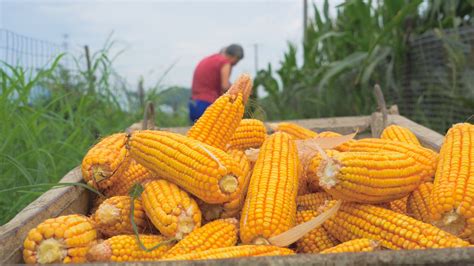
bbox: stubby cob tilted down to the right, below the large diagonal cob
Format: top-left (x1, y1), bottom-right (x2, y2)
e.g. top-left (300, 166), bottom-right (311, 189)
top-left (142, 180), bottom-right (201, 239)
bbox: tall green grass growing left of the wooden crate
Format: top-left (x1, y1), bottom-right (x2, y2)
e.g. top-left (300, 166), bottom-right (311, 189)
top-left (0, 47), bottom-right (187, 224)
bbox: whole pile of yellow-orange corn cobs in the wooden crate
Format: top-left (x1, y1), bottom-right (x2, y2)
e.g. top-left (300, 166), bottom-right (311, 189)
top-left (23, 75), bottom-right (474, 263)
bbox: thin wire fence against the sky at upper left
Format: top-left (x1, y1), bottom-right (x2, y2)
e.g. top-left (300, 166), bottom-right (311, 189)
top-left (0, 29), bottom-right (65, 71)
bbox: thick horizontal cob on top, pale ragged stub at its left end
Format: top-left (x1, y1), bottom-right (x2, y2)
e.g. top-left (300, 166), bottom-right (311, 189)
top-left (318, 152), bottom-right (422, 203)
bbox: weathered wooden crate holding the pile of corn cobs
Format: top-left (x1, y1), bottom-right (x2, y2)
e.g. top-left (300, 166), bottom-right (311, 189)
top-left (0, 113), bottom-right (474, 265)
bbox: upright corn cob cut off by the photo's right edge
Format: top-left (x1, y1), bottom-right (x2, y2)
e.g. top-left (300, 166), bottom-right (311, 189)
top-left (430, 123), bottom-right (474, 242)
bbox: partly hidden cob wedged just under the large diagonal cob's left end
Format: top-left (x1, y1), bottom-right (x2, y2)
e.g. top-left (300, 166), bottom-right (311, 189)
top-left (104, 158), bottom-right (157, 197)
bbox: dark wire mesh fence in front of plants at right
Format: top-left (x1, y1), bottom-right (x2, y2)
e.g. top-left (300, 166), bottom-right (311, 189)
top-left (389, 27), bottom-right (474, 132)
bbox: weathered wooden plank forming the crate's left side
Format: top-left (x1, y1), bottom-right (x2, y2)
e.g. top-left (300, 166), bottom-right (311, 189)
top-left (0, 167), bottom-right (89, 264)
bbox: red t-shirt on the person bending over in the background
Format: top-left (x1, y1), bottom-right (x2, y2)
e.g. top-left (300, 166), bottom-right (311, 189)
top-left (191, 54), bottom-right (230, 103)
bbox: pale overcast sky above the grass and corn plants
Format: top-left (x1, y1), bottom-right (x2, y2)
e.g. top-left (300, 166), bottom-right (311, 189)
top-left (0, 0), bottom-right (341, 87)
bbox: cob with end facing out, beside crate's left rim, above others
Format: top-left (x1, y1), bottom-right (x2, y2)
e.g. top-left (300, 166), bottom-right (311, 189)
top-left (81, 133), bottom-right (127, 190)
